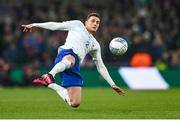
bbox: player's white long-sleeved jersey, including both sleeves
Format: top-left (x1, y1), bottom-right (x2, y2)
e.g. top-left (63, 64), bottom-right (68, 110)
top-left (31, 20), bottom-right (114, 86)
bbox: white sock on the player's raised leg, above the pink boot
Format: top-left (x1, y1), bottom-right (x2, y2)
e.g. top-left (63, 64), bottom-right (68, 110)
top-left (49, 62), bottom-right (66, 77)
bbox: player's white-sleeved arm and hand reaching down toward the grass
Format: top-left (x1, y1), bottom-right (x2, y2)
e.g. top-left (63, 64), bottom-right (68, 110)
top-left (92, 50), bottom-right (125, 95)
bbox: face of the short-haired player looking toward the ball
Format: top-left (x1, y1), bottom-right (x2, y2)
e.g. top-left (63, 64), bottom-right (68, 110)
top-left (85, 16), bottom-right (100, 33)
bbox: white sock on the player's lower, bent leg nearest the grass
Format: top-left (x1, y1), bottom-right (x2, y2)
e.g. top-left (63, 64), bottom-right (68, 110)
top-left (48, 83), bottom-right (71, 105)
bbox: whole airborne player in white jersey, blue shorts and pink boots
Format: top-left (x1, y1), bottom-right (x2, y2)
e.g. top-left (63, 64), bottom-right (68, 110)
top-left (21, 13), bottom-right (124, 107)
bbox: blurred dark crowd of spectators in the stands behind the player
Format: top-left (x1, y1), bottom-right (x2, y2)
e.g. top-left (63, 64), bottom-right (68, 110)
top-left (0, 0), bottom-right (180, 84)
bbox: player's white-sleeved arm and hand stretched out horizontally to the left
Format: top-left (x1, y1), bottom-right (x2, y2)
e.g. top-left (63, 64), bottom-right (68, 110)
top-left (21, 20), bottom-right (81, 32)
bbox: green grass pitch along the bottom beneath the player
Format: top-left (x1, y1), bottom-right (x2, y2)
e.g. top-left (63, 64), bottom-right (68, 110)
top-left (0, 87), bottom-right (180, 119)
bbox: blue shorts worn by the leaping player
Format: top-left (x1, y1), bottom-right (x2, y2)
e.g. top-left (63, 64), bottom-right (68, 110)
top-left (54, 49), bottom-right (83, 88)
